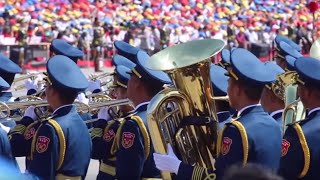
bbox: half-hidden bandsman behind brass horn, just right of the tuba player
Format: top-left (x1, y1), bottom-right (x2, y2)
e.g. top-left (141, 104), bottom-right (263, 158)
top-left (261, 62), bottom-right (285, 129)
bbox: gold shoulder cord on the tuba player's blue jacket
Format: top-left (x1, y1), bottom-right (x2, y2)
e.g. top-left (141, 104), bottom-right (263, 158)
top-left (231, 121), bottom-right (249, 166)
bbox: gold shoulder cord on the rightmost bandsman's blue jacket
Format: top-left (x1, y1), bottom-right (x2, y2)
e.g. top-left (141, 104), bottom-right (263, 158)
top-left (292, 123), bottom-right (310, 178)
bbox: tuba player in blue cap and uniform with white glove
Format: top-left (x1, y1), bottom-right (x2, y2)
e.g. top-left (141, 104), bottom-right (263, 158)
top-left (154, 48), bottom-right (281, 179)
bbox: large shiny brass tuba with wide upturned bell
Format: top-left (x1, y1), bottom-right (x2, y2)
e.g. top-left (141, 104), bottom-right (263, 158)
top-left (146, 39), bottom-right (227, 179)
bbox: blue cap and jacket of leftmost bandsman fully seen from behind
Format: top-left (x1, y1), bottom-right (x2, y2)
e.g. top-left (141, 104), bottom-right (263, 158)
top-left (28, 55), bottom-right (91, 179)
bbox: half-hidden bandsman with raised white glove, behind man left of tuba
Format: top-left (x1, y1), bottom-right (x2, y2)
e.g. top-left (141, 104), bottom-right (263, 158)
top-left (91, 65), bottom-right (132, 180)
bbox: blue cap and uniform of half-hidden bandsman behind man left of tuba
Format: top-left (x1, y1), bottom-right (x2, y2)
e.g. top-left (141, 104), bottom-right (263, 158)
top-left (91, 64), bottom-right (131, 180)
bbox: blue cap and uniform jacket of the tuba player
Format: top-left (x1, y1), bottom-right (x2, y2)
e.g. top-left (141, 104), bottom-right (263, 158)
top-left (176, 48), bottom-right (281, 179)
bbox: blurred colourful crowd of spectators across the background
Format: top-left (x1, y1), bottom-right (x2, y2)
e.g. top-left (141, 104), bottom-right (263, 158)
top-left (0, 0), bottom-right (320, 56)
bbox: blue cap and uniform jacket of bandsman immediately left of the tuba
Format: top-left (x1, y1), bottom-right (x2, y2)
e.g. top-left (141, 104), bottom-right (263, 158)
top-left (114, 51), bottom-right (171, 180)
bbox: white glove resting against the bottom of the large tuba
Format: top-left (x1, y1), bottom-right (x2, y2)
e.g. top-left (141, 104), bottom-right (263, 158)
top-left (153, 144), bottom-right (181, 174)
